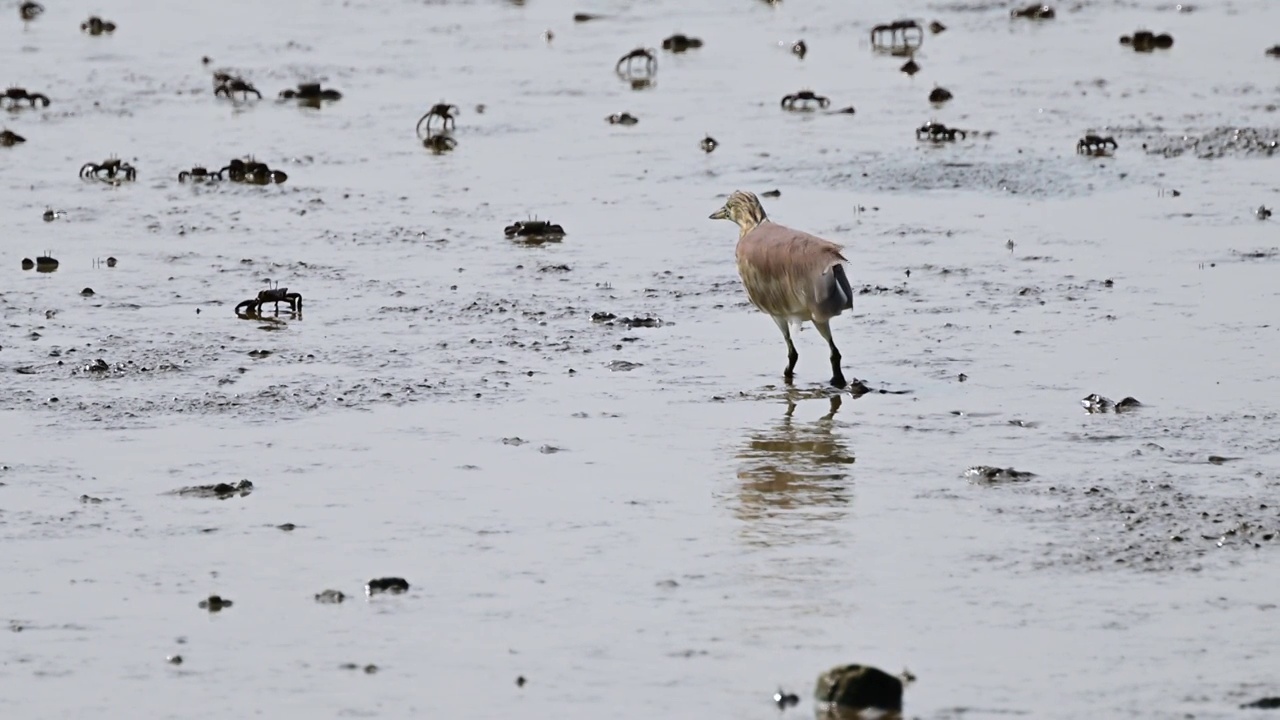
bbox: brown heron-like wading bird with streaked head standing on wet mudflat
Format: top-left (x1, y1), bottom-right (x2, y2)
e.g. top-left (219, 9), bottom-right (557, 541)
top-left (710, 191), bottom-right (854, 387)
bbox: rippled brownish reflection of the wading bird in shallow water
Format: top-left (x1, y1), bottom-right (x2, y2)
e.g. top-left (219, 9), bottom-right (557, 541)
top-left (736, 395), bottom-right (854, 542)
